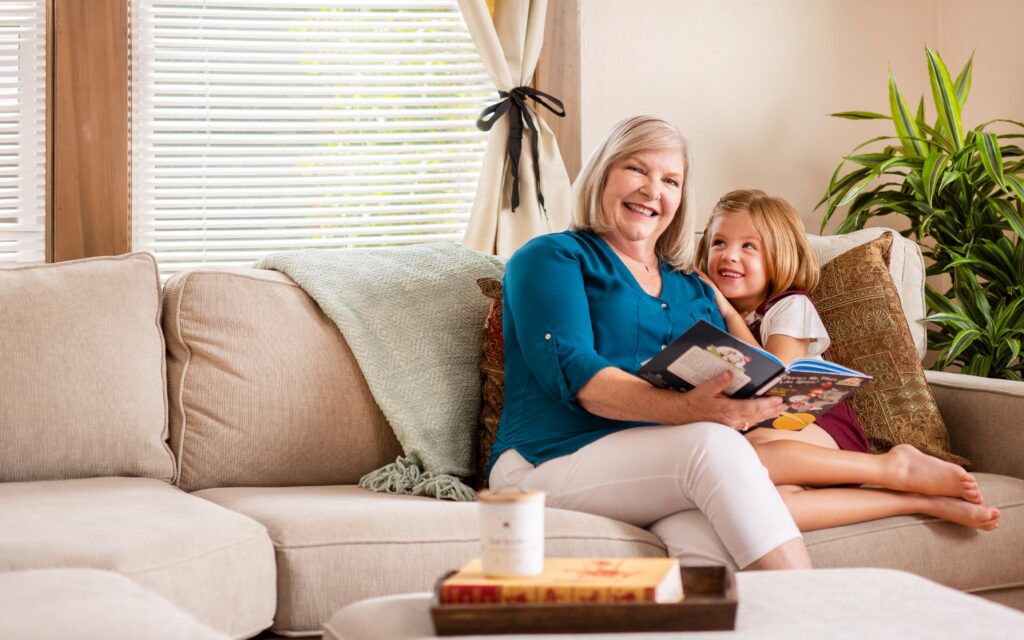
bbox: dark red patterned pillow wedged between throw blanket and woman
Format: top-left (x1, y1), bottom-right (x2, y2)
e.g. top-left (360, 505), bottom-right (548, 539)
top-left (476, 278), bottom-right (505, 489)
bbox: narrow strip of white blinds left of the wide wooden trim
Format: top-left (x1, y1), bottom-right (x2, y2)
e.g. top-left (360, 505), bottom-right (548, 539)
top-left (0, 0), bottom-right (47, 263)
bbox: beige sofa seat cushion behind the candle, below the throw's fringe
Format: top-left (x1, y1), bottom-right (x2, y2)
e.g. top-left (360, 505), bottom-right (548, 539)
top-left (195, 485), bottom-right (666, 634)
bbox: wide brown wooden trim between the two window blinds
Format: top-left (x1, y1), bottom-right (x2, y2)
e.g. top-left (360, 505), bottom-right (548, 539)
top-left (51, 0), bottom-right (131, 261)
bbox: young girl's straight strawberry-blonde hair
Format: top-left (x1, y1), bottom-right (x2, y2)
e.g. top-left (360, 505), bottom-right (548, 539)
top-left (696, 188), bottom-right (820, 295)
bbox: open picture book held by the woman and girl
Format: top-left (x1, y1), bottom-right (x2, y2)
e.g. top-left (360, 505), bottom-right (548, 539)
top-left (637, 321), bottom-right (871, 429)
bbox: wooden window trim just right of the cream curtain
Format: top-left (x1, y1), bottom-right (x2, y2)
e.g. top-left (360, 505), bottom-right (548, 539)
top-left (534, 0), bottom-right (583, 180)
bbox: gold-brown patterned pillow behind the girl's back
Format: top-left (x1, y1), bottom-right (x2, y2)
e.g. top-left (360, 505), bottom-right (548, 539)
top-left (811, 233), bottom-right (970, 467)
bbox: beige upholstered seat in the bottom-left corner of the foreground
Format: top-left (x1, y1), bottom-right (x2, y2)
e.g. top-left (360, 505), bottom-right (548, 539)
top-left (0, 569), bottom-right (228, 640)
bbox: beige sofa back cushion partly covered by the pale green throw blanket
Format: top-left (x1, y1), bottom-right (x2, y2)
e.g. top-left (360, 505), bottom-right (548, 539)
top-left (164, 268), bottom-right (401, 492)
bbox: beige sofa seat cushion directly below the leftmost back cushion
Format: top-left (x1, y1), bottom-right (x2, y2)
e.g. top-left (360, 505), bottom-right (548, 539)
top-left (0, 478), bottom-right (276, 636)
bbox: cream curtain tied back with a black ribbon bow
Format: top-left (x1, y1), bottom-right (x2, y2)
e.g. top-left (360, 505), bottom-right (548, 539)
top-left (459, 0), bottom-right (571, 256)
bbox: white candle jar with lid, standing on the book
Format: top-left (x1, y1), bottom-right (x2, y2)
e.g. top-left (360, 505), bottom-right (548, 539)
top-left (479, 489), bottom-right (544, 578)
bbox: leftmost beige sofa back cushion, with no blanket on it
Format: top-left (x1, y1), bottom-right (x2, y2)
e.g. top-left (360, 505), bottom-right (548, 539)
top-left (0, 253), bottom-right (174, 482)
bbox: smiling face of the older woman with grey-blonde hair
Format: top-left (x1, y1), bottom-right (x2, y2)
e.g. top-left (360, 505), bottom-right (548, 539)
top-left (601, 148), bottom-right (684, 252)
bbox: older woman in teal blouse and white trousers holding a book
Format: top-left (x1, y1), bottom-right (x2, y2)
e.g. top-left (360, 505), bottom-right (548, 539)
top-left (489, 117), bottom-right (810, 568)
